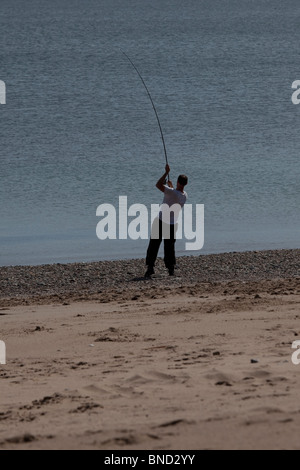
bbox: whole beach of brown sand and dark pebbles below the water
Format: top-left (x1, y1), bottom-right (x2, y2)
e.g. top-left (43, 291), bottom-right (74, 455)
top-left (0, 250), bottom-right (300, 450)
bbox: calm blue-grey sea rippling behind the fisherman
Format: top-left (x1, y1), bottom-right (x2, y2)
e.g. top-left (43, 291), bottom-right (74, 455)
top-left (0, 0), bottom-right (300, 265)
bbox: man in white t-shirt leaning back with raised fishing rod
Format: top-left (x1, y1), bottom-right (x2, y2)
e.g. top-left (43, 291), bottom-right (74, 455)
top-left (145, 165), bottom-right (188, 279)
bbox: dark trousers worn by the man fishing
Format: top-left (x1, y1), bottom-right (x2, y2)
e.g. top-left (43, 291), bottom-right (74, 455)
top-left (146, 219), bottom-right (177, 269)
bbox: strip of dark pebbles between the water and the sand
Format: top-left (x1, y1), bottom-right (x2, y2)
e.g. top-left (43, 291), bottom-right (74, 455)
top-left (0, 249), bottom-right (300, 307)
